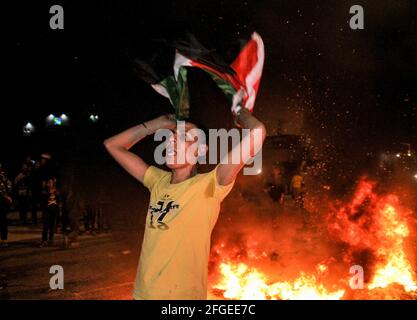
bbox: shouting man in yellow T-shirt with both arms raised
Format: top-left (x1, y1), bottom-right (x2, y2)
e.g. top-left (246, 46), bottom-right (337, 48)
top-left (104, 109), bottom-right (266, 300)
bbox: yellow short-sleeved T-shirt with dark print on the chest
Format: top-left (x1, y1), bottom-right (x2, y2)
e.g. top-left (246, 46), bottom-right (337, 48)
top-left (133, 166), bottom-right (234, 300)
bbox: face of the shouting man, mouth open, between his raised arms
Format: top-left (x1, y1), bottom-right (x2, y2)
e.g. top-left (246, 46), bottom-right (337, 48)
top-left (166, 122), bottom-right (205, 169)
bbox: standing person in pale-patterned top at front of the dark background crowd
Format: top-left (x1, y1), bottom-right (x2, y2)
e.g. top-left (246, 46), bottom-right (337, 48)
top-left (40, 178), bottom-right (59, 247)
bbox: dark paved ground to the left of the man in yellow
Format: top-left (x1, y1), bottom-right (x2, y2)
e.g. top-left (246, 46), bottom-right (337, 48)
top-left (0, 213), bottom-right (140, 300)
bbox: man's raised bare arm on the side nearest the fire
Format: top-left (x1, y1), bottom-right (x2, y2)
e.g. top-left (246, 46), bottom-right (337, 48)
top-left (217, 109), bottom-right (266, 186)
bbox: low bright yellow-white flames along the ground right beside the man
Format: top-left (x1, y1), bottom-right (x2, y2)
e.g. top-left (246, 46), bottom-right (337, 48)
top-left (214, 263), bottom-right (345, 300)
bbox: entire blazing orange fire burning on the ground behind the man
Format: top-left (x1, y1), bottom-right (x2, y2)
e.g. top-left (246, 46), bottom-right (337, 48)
top-left (212, 178), bottom-right (417, 300)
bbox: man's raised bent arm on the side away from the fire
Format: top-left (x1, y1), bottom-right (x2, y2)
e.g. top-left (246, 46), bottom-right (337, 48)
top-left (104, 115), bottom-right (175, 183)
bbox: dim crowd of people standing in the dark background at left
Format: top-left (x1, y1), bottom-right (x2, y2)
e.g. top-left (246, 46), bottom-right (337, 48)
top-left (0, 153), bottom-right (110, 248)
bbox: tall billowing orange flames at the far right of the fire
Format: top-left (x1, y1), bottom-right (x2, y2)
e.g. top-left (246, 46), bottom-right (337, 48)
top-left (329, 178), bottom-right (417, 292)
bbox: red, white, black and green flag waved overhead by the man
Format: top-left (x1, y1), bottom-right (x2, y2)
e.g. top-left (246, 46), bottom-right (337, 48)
top-left (135, 33), bottom-right (265, 119)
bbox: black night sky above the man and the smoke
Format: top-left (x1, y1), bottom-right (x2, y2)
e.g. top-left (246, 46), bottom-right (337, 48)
top-left (4, 0), bottom-right (417, 180)
